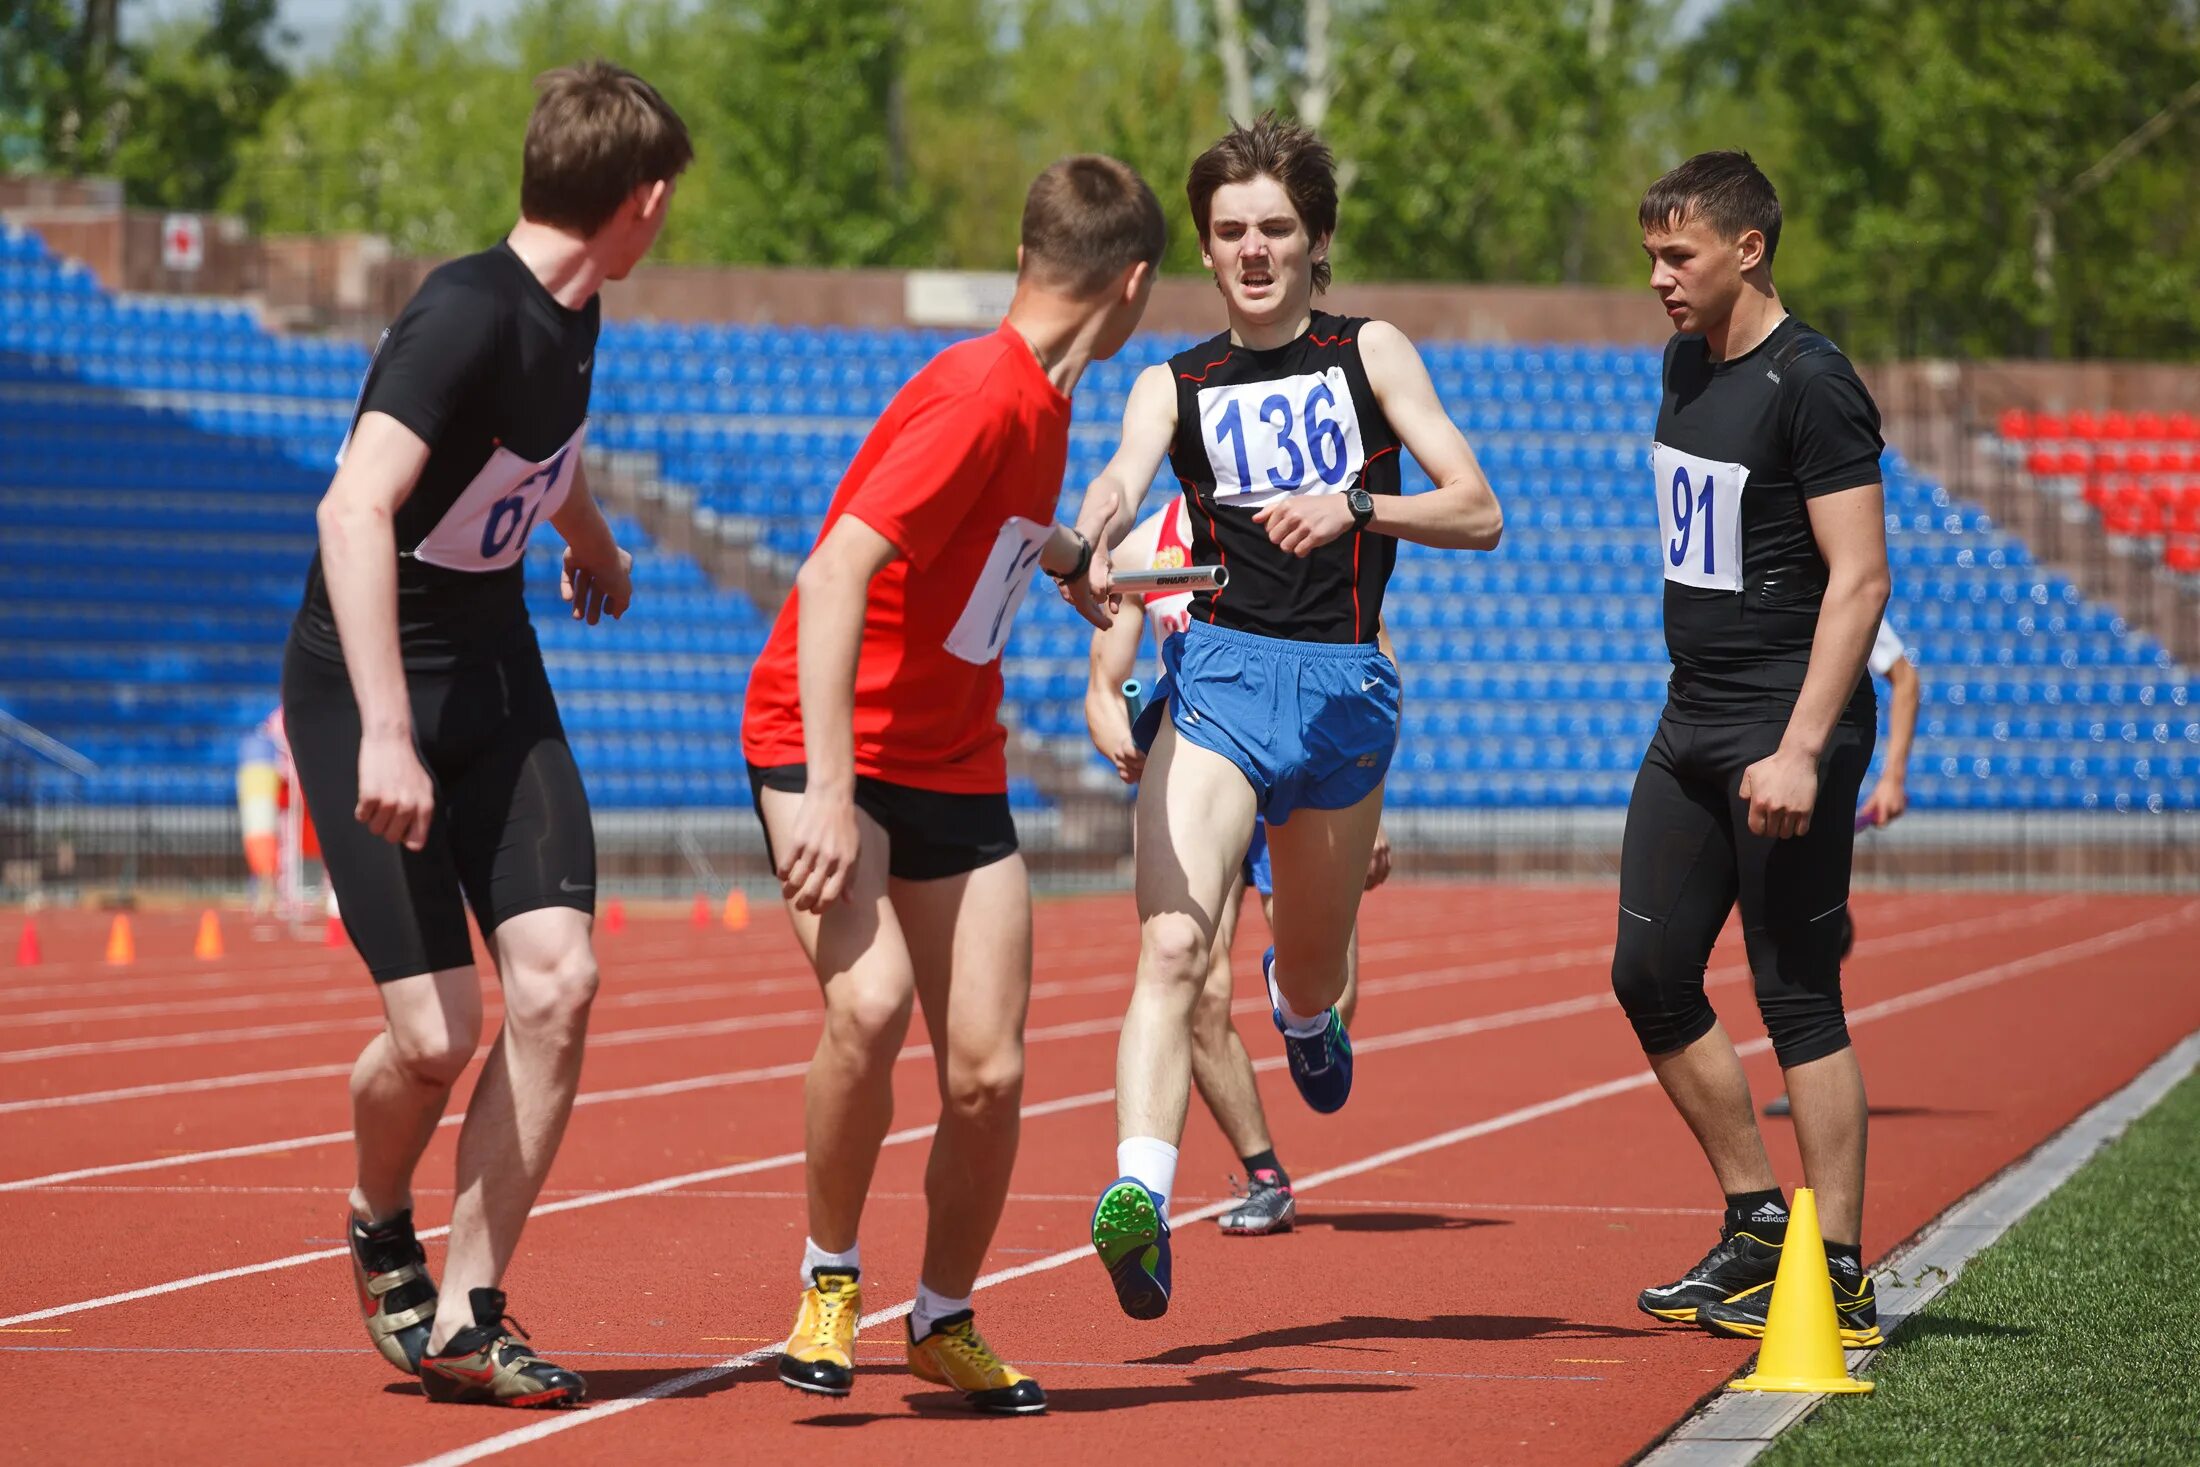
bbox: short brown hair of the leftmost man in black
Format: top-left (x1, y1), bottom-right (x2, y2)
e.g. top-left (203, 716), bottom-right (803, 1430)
top-left (519, 62), bottom-right (695, 235)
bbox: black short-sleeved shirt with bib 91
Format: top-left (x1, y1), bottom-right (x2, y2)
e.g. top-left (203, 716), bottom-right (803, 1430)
top-left (1652, 317), bottom-right (1883, 724)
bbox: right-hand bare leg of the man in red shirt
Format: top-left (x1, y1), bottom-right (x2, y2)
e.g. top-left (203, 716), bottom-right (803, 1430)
top-left (889, 856), bottom-right (1032, 1298)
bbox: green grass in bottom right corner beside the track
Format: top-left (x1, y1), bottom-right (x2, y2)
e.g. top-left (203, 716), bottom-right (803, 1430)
top-left (1758, 1076), bottom-right (2200, 1467)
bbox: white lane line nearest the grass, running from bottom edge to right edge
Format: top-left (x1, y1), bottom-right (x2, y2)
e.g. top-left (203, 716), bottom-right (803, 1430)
top-left (387, 906), bottom-right (2193, 1467)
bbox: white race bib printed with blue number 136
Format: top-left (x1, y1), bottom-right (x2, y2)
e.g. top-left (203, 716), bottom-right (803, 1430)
top-left (1199, 367), bottom-right (1366, 510)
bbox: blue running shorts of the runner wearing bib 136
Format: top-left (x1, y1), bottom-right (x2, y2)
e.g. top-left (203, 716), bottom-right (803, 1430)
top-left (1135, 622), bottom-right (1399, 825)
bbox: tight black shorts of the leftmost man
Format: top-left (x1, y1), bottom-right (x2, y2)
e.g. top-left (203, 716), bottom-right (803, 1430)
top-left (282, 629), bottom-right (596, 983)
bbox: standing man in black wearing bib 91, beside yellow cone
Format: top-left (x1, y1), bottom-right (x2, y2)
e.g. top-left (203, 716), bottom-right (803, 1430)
top-left (1613, 152), bottom-right (1888, 1346)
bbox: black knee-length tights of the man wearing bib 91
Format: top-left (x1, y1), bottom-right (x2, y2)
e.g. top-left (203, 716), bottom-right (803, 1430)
top-left (1613, 717), bottom-right (1874, 1067)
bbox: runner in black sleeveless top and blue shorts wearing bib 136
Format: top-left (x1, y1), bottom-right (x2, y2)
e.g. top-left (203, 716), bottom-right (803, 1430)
top-left (1051, 117), bottom-right (1503, 1317)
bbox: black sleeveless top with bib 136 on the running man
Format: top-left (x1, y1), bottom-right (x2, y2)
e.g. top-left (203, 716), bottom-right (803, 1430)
top-left (1168, 310), bottom-right (1399, 642)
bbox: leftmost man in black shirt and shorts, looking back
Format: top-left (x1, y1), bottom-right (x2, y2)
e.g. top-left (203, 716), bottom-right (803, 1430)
top-left (284, 62), bottom-right (693, 1405)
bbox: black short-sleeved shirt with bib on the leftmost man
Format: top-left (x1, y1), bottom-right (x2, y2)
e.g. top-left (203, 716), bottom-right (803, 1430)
top-left (293, 242), bottom-right (601, 671)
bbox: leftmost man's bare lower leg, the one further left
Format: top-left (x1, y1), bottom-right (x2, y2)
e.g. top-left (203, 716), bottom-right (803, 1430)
top-left (350, 968), bottom-right (482, 1223)
